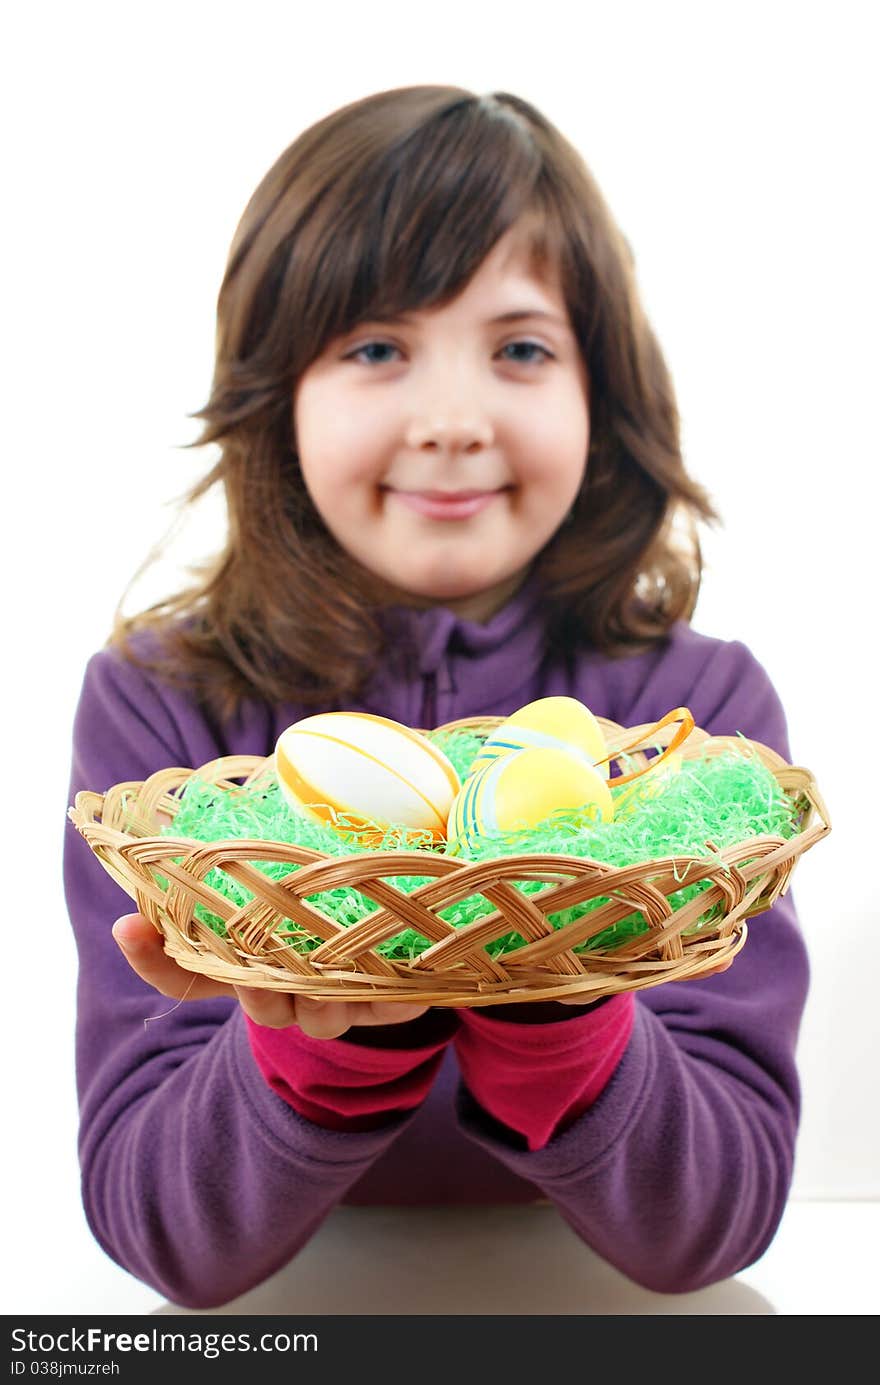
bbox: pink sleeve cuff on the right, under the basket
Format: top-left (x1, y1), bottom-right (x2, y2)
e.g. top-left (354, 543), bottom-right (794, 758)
top-left (455, 992), bottom-right (635, 1150)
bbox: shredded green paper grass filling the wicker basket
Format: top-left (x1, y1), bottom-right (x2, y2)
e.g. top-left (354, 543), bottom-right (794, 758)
top-left (157, 731), bottom-right (800, 960)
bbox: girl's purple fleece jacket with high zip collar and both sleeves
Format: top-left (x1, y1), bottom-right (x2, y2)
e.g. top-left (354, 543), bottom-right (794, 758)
top-left (64, 580), bottom-right (808, 1307)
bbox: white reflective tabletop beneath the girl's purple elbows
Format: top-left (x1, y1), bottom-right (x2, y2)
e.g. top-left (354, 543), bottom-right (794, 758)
top-left (152, 1202), bottom-right (880, 1316)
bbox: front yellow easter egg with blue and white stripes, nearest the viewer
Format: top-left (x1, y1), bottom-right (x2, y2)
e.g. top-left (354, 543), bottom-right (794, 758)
top-left (448, 747), bottom-right (614, 845)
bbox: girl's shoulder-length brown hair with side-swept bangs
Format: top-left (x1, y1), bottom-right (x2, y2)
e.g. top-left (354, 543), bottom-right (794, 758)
top-left (108, 86), bottom-right (718, 717)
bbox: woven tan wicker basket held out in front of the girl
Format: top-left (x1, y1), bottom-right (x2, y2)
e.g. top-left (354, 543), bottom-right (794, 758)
top-left (68, 717), bottom-right (830, 1007)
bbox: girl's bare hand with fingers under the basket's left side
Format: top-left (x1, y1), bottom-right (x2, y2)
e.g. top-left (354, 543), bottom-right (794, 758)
top-left (112, 914), bottom-right (428, 1039)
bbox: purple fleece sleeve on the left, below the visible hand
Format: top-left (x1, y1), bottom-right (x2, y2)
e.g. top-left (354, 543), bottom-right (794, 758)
top-left (64, 651), bottom-right (424, 1307)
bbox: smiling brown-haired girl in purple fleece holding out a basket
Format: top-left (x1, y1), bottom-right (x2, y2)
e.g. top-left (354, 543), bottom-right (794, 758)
top-left (65, 86), bottom-right (808, 1307)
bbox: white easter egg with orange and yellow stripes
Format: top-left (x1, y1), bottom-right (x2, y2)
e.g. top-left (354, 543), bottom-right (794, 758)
top-left (274, 712), bottom-right (460, 841)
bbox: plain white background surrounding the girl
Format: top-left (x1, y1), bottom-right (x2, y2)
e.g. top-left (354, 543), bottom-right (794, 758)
top-left (0, 0), bottom-right (880, 1314)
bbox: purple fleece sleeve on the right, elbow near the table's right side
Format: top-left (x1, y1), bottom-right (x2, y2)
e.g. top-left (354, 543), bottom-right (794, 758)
top-left (459, 641), bottom-right (808, 1292)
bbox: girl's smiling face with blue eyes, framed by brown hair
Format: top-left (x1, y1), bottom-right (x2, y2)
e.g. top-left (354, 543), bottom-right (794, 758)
top-left (294, 231), bottom-right (589, 620)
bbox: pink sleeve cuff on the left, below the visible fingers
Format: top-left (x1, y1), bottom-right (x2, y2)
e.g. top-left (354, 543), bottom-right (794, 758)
top-left (245, 1011), bottom-right (457, 1130)
